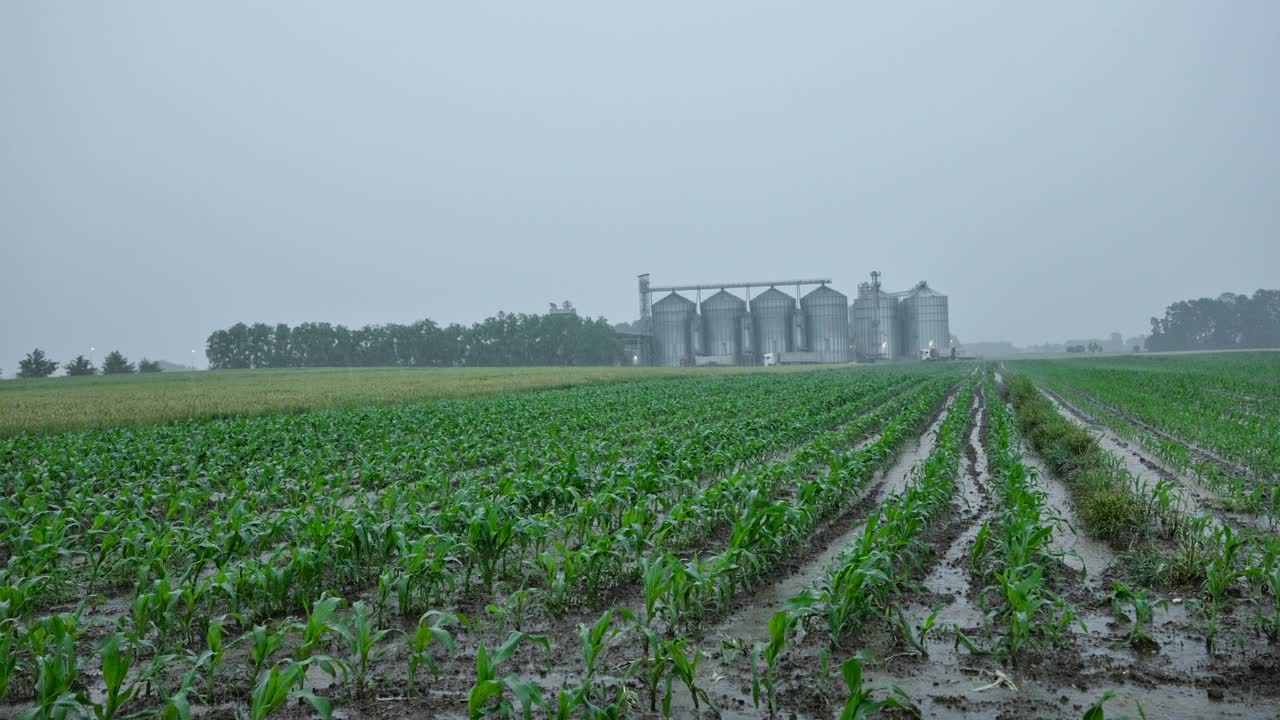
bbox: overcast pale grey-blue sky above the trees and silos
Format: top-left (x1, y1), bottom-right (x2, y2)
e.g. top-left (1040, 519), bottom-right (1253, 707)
top-left (0, 0), bottom-right (1280, 375)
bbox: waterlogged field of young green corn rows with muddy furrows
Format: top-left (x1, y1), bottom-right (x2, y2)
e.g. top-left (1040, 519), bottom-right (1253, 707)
top-left (0, 356), bottom-right (1280, 720)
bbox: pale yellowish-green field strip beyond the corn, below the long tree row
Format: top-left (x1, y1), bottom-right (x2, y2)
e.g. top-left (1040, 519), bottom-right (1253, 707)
top-left (0, 366), bottom-right (829, 437)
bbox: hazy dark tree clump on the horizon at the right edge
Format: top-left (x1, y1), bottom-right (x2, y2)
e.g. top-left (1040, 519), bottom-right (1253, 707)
top-left (1147, 290), bottom-right (1280, 351)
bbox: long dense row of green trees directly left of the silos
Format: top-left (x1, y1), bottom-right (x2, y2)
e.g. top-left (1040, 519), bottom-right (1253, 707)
top-left (205, 313), bottom-right (622, 369)
